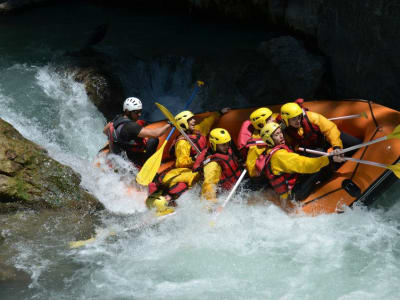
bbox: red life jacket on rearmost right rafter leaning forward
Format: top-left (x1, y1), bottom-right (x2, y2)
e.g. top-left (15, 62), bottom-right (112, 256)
top-left (286, 108), bottom-right (325, 148)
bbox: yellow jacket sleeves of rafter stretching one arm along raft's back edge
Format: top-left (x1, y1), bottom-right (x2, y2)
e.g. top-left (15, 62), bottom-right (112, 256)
top-left (175, 112), bottom-right (220, 168)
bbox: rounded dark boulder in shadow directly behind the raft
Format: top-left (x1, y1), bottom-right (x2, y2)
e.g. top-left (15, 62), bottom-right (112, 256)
top-left (193, 36), bottom-right (327, 109)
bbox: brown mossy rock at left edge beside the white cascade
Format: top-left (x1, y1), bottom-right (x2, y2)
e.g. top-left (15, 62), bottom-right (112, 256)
top-left (0, 119), bottom-right (102, 212)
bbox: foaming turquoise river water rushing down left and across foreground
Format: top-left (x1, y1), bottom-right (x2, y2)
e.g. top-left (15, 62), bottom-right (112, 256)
top-left (0, 2), bottom-right (400, 300)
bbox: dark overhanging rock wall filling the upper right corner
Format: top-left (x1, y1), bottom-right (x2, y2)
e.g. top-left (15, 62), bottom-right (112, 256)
top-left (188, 0), bottom-right (400, 108)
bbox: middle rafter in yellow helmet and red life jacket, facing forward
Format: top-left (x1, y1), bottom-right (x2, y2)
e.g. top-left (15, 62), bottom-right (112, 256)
top-left (194, 128), bottom-right (243, 204)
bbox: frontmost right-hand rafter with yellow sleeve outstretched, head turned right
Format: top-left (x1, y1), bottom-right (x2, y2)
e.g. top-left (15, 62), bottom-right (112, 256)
top-left (256, 122), bottom-right (344, 201)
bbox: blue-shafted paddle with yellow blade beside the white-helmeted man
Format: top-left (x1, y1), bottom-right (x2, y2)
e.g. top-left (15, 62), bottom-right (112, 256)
top-left (136, 81), bottom-right (204, 185)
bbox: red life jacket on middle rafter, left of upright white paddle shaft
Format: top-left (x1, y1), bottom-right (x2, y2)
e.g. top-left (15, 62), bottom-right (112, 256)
top-left (202, 149), bottom-right (242, 190)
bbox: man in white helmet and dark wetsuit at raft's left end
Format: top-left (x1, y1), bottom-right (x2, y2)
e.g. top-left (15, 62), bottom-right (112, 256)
top-left (103, 97), bottom-right (171, 167)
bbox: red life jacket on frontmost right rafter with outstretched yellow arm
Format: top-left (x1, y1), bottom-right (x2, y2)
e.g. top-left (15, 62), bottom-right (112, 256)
top-left (264, 145), bottom-right (297, 195)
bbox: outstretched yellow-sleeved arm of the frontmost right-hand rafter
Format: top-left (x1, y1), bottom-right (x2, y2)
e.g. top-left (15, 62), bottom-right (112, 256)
top-left (271, 149), bottom-right (329, 175)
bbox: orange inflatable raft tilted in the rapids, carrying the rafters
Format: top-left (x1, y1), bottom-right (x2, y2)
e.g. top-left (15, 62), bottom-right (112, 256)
top-left (99, 100), bottom-right (400, 215)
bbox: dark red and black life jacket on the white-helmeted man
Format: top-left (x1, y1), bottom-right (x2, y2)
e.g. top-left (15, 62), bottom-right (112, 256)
top-left (107, 116), bottom-right (146, 154)
